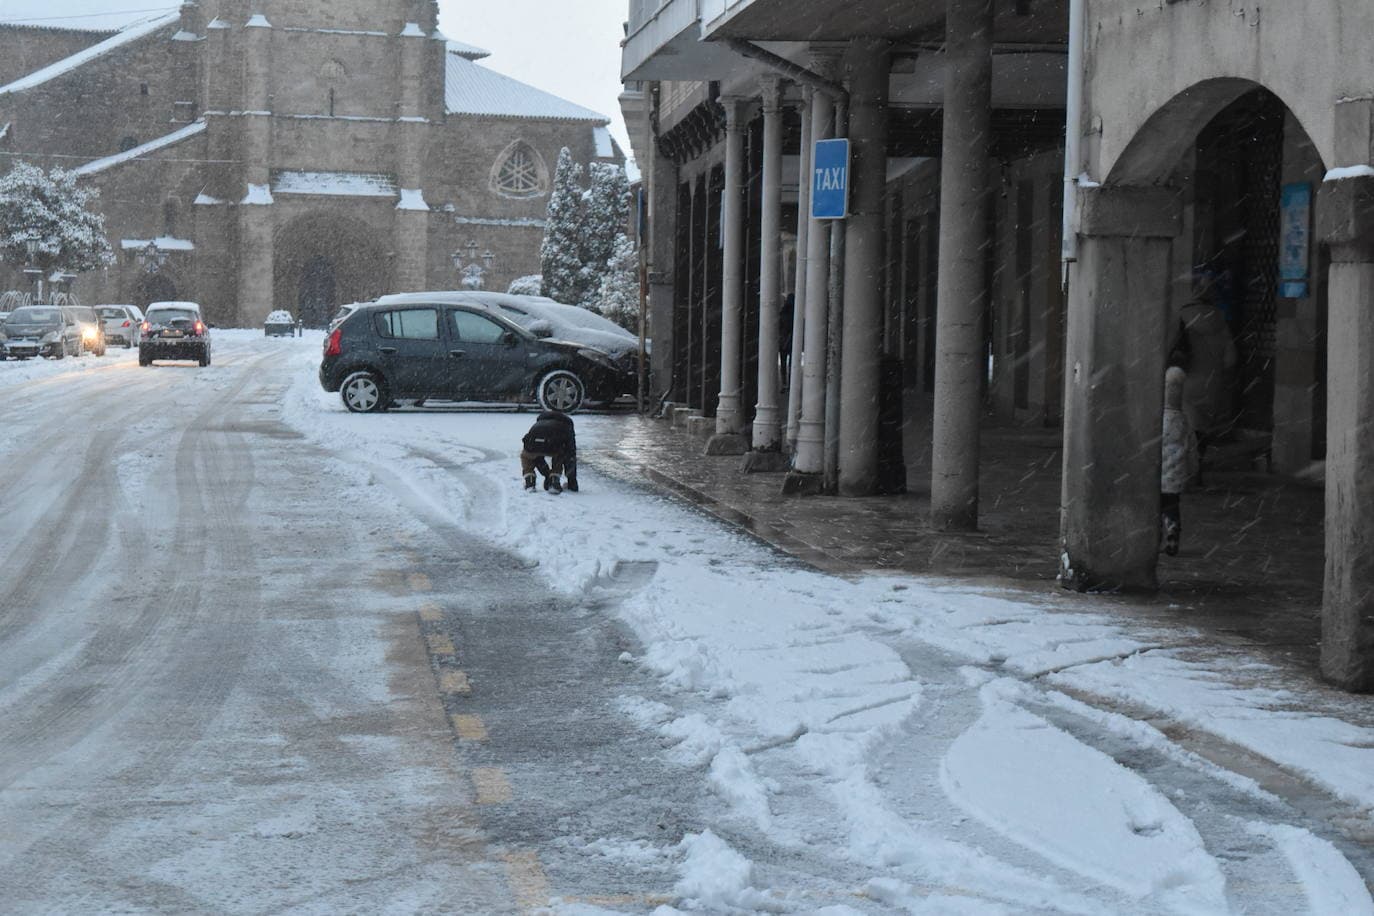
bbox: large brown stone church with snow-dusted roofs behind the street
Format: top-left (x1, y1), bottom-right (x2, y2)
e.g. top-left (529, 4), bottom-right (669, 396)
top-left (0, 0), bottom-right (624, 325)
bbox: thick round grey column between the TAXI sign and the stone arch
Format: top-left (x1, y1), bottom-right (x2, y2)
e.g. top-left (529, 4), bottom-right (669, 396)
top-left (930, 0), bottom-right (992, 531)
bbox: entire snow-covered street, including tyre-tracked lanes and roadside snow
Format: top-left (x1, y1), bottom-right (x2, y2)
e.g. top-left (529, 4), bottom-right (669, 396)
top-left (0, 332), bottom-right (1374, 916)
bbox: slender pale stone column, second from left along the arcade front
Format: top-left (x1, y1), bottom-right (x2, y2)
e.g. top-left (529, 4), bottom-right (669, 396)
top-left (745, 76), bottom-right (787, 471)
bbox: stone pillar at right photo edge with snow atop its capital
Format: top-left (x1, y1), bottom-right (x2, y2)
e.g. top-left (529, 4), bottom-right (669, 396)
top-left (1318, 171), bottom-right (1374, 692)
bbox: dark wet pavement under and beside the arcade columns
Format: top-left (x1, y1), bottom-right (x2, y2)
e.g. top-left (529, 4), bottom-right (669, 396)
top-left (588, 416), bottom-right (1323, 674)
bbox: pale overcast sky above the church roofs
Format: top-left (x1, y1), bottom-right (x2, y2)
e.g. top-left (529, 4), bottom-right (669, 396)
top-left (0, 0), bottom-right (629, 155)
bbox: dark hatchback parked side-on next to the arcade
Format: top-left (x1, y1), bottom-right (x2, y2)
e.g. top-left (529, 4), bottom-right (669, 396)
top-left (320, 293), bottom-right (620, 412)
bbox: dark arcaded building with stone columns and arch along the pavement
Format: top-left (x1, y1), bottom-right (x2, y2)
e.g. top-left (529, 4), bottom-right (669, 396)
top-left (622, 0), bottom-right (1374, 691)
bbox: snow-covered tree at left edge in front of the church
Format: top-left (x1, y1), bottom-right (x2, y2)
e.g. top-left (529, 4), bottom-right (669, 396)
top-left (0, 162), bottom-right (114, 273)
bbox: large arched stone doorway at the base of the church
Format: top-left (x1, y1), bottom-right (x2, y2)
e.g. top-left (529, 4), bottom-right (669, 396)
top-left (273, 213), bottom-right (392, 328)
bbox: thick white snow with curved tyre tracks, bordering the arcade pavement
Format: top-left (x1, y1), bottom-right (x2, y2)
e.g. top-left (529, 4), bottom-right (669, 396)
top-left (262, 336), bottom-right (1374, 913)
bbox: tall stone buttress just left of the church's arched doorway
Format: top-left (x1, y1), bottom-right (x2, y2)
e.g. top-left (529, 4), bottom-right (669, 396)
top-left (238, 4), bottom-right (276, 327)
